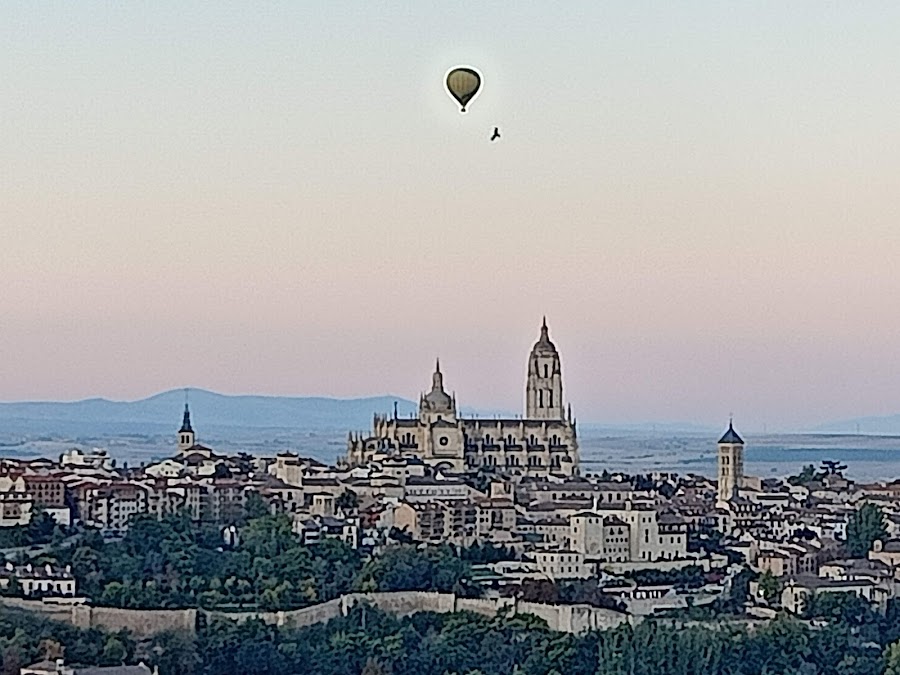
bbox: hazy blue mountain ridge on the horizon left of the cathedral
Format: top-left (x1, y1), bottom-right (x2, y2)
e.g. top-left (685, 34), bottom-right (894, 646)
top-left (0, 389), bottom-right (416, 435)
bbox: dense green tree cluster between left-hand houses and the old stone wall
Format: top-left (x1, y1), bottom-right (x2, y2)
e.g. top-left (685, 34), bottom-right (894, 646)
top-left (41, 515), bottom-right (477, 611)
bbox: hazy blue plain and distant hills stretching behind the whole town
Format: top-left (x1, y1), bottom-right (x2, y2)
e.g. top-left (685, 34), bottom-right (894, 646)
top-left (0, 389), bottom-right (900, 481)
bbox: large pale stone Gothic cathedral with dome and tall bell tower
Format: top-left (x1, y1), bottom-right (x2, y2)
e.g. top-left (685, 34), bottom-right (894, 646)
top-left (342, 319), bottom-right (578, 478)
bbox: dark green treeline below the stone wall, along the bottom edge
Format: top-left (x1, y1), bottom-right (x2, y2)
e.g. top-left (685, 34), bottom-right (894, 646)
top-left (0, 603), bottom-right (900, 675)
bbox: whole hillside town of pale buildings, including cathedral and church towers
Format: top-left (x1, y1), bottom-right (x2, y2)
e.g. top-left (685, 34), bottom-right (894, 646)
top-left (0, 320), bottom-right (900, 636)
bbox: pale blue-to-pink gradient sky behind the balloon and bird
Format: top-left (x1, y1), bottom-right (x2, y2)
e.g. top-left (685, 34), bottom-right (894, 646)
top-left (0, 0), bottom-right (900, 430)
